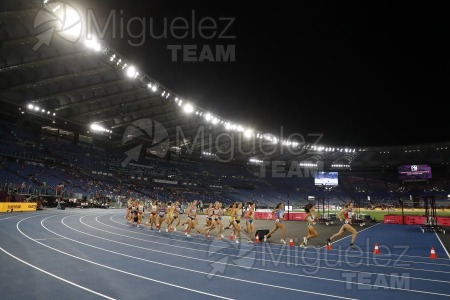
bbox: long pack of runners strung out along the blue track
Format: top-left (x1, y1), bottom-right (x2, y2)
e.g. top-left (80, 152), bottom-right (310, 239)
top-left (125, 199), bottom-right (358, 249)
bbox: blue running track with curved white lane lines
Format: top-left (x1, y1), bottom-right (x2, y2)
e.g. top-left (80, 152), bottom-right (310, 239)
top-left (0, 209), bottom-right (450, 300)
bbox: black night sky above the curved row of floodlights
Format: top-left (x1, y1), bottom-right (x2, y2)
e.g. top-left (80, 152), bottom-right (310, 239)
top-left (77, 0), bottom-right (450, 146)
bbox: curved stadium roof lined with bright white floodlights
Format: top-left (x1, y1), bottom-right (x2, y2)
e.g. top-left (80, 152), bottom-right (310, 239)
top-left (0, 0), bottom-right (449, 168)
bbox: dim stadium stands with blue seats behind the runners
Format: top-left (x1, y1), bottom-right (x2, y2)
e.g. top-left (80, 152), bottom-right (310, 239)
top-left (0, 121), bottom-right (448, 207)
